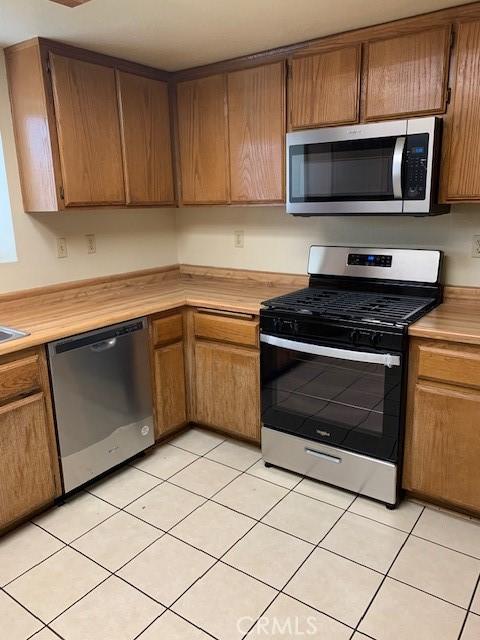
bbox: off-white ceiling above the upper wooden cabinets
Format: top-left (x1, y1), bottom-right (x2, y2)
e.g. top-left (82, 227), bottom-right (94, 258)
top-left (0, 0), bottom-right (472, 71)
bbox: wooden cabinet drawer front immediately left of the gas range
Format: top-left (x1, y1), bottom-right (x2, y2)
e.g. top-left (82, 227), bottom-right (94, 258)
top-left (194, 312), bottom-right (258, 347)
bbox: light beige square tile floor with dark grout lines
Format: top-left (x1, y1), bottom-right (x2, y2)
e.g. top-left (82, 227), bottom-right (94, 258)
top-left (0, 429), bottom-right (480, 640)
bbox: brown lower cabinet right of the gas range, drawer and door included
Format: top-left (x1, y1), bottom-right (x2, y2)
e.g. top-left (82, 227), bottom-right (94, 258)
top-left (403, 339), bottom-right (480, 513)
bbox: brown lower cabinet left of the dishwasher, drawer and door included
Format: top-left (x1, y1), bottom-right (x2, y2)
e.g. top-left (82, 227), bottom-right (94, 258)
top-left (0, 350), bottom-right (60, 530)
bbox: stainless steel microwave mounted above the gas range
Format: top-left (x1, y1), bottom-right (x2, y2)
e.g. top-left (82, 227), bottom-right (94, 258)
top-left (286, 117), bottom-right (450, 216)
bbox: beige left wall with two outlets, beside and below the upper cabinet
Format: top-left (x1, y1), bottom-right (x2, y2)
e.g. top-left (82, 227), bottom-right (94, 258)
top-left (0, 51), bottom-right (177, 294)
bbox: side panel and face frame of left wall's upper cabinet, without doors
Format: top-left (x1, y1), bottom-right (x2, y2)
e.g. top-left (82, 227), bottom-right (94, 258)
top-left (5, 38), bottom-right (175, 213)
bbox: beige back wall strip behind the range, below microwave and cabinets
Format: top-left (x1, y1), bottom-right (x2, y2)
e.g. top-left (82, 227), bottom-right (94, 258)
top-left (177, 205), bottom-right (480, 286)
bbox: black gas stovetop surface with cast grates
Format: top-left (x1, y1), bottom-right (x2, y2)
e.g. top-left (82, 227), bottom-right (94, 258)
top-left (262, 287), bottom-right (435, 324)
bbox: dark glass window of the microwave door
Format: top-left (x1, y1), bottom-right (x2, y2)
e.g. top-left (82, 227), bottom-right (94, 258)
top-left (289, 136), bottom-right (397, 202)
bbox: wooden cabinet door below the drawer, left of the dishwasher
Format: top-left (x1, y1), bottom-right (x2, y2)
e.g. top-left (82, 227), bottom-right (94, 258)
top-left (0, 393), bottom-right (55, 529)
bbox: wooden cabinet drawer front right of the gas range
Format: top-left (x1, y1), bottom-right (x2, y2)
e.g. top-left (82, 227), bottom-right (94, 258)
top-left (418, 346), bottom-right (480, 388)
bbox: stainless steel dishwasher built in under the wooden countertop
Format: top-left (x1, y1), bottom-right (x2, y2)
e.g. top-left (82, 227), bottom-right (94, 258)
top-left (48, 318), bottom-right (154, 493)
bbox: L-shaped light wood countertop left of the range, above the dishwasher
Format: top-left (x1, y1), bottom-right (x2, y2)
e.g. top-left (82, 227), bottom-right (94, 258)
top-left (0, 267), bottom-right (307, 355)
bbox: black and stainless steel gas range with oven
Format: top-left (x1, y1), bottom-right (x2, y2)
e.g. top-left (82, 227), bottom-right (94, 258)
top-left (260, 246), bottom-right (442, 507)
